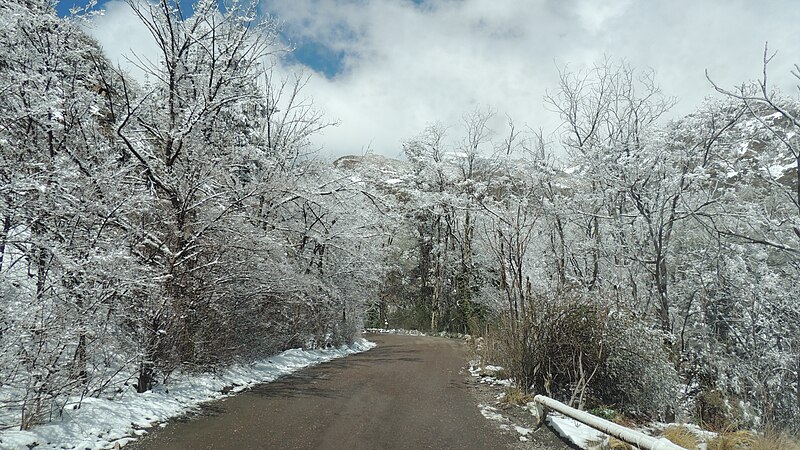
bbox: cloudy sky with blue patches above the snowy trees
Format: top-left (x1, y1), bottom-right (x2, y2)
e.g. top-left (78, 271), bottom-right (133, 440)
top-left (75, 0), bottom-right (800, 157)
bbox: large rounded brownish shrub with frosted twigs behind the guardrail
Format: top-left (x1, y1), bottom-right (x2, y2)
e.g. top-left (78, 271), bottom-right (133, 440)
top-left (503, 297), bottom-right (678, 417)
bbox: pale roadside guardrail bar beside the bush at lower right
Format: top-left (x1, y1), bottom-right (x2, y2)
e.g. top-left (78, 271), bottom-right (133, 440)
top-left (533, 395), bottom-right (686, 450)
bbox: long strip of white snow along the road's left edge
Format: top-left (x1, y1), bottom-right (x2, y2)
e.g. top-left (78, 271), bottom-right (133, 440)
top-left (0, 339), bottom-right (375, 450)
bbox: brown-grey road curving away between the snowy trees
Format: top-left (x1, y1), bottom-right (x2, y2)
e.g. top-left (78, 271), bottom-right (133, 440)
top-left (131, 335), bottom-right (518, 449)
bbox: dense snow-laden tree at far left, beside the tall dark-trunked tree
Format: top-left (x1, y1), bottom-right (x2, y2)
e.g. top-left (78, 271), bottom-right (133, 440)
top-left (0, 2), bottom-right (141, 428)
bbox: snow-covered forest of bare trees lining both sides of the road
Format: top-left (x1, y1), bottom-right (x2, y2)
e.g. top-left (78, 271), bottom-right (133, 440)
top-left (0, 0), bottom-right (800, 438)
